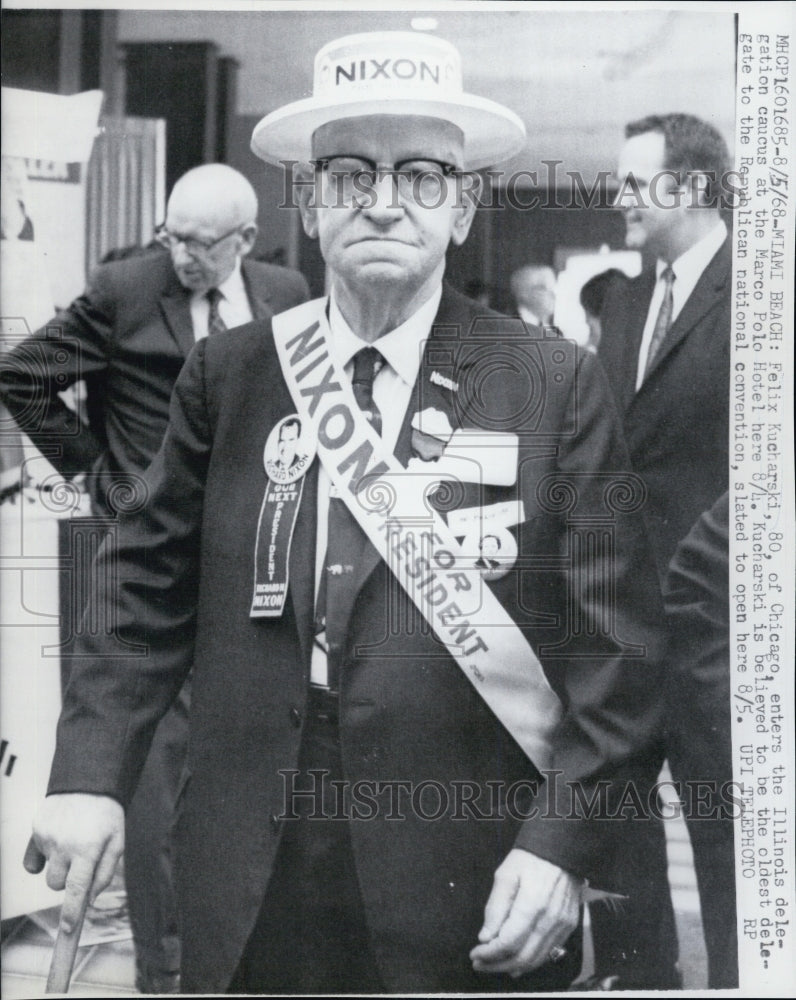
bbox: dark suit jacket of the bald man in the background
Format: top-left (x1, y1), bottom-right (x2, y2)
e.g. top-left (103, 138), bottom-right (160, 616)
top-left (0, 249), bottom-right (308, 510)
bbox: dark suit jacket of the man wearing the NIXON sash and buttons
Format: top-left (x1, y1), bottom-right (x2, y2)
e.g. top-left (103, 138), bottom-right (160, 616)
top-left (50, 289), bottom-right (662, 993)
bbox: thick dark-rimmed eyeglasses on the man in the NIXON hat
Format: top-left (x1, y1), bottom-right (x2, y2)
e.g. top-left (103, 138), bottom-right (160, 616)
top-left (312, 156), bottom-right (460, 207)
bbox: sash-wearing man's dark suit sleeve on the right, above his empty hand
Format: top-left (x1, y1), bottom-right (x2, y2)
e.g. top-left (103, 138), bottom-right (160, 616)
top-left (517, 355), bottom-right (666, 891)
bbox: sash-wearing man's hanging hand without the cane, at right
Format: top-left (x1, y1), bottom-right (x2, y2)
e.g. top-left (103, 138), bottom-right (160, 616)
top-left (470, 848), bottom-right (582, 977)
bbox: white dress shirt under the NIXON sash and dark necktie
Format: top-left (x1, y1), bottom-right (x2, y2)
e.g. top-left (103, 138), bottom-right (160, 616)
top-left (310, 285), bottom-right (442, 686)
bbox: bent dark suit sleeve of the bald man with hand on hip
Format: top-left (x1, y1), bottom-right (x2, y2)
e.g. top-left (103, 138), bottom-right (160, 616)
top-left (0, 267), bottom-right (115, 478)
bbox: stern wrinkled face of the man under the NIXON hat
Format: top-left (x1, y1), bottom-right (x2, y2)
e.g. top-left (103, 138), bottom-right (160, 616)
top-left (302, 115), bottom-right (477, 289)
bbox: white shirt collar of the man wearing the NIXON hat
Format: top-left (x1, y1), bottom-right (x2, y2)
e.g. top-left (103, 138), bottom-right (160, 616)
top-left (329, 285), bottom-right (442, 387)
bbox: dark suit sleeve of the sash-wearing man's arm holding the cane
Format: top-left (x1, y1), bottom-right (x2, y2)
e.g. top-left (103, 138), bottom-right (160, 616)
top-left (48, 341), bottom-right (211, 806)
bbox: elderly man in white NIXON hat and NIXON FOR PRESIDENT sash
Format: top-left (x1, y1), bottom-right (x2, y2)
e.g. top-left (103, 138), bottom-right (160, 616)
top-left (27, 32), bottom-right (662, 993)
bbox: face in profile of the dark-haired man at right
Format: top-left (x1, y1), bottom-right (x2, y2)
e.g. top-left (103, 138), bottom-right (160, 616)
top-left (615, 132), bottom-right (685, 259)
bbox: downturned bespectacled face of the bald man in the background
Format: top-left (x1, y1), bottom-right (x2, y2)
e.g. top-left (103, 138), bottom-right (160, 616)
top-left (161, 193), bottom-right (253, 292)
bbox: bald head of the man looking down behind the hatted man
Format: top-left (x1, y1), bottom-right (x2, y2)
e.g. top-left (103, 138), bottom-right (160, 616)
top-left (164, 163), bottom-right (257, 292)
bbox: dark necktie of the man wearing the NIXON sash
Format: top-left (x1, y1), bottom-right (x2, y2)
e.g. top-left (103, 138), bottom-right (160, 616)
top-left (315, 347), bottom-right (384, 691)
